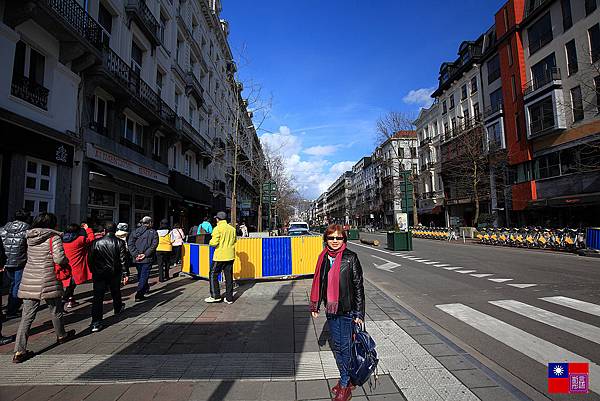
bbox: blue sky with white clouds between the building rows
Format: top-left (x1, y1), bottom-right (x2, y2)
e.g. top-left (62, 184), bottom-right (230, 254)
top-left (222, 0), bottom-right (504, 199)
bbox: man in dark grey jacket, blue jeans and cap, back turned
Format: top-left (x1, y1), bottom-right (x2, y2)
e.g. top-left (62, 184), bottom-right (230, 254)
top-left (127, 216), bottom-right (158, 301)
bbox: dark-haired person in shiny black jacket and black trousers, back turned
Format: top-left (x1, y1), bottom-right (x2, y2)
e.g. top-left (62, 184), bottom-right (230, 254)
top-left (89, 222), bottom-right (129, 333)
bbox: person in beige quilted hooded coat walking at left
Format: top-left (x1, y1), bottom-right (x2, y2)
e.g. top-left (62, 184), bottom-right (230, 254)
top-left (13, 213), bottom-right (75, 363)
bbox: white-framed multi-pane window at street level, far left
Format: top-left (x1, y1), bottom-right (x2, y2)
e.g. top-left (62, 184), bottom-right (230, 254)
top-left (23, 158), bottom-right (56, 216)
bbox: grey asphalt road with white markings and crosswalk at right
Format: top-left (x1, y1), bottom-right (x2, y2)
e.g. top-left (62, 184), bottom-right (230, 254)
top-left (350, 233), bottom-right (600, 400)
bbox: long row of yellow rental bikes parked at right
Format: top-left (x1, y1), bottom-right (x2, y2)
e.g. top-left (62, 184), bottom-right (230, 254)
top-left (475, 227), bottom-right (585, 252)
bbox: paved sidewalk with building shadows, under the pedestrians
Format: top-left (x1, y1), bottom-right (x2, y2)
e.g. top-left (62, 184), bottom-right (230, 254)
top-left (0, 264), bottom-right (515, 401)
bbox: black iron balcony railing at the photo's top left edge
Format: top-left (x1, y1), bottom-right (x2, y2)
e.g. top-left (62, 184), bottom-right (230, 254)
top-left (42, 0), bottom-right (102, 49)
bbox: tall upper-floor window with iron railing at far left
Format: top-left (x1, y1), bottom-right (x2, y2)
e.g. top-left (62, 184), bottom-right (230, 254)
top-left (11, 40), bottom-right (49, 110)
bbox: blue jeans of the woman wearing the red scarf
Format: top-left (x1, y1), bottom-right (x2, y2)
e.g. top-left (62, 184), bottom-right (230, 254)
top-left (327, 314), bottom-right (352, 387)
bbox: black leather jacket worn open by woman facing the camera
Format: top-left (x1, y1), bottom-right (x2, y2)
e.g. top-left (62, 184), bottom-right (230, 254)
top-left (317, 249), bottom-right (365, 320)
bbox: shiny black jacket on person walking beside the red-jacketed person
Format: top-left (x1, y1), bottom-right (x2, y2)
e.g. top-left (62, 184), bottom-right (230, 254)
top-left (88, 233), bottom-right (129, 278)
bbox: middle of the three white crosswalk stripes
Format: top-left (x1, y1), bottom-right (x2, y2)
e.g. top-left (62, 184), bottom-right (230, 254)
top-left (489, 299), bottom-right (600, 344)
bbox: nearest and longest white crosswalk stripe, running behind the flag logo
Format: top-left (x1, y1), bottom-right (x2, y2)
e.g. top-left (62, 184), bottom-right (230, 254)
top-left (436, 304), bottom-right (600, 394)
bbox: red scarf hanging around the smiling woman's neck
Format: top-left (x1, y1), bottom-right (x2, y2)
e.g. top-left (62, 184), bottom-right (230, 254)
top-left (310, 244), bottom-right (346, 314)
